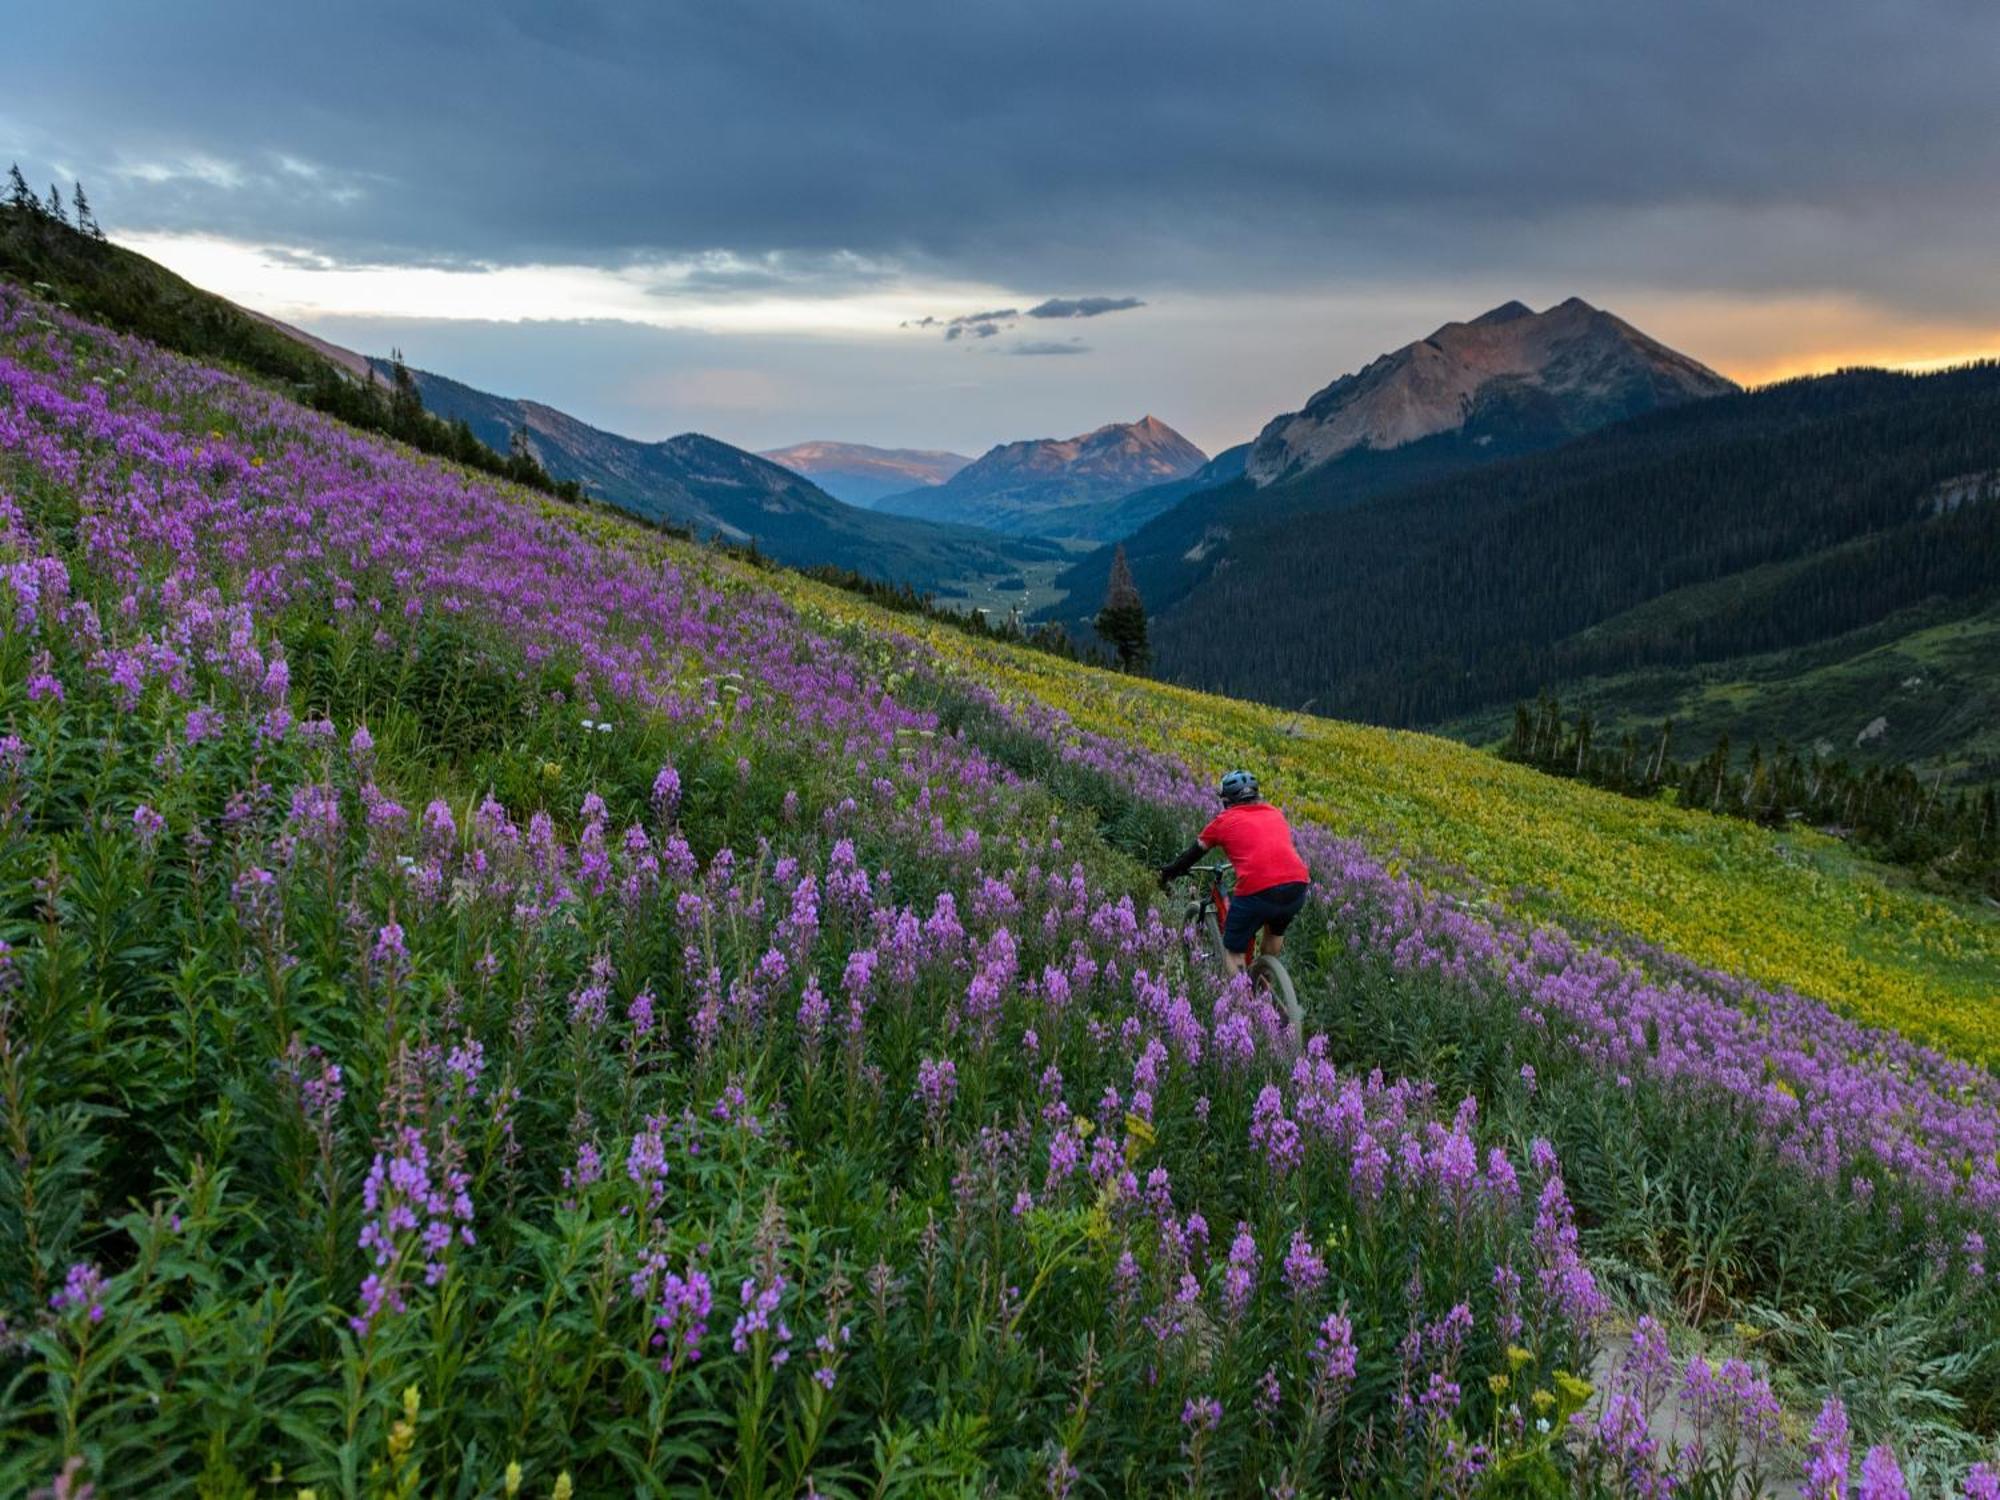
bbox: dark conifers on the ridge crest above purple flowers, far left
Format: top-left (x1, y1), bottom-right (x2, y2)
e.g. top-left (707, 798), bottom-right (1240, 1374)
top-left (0, 166), bottom-right (584, 500)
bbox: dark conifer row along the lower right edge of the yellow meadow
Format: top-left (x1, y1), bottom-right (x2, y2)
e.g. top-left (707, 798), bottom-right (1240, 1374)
top-left (1500, 692), bottom-right (2000, 900)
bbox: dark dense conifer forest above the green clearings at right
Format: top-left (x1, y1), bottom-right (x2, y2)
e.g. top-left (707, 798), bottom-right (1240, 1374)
top-left (1154, 362), bottom-right (2000, 724)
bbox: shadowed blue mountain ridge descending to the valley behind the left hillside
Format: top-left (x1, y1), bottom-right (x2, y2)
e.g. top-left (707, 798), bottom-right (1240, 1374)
top-left (374, 360), bottom-right (1054, 588)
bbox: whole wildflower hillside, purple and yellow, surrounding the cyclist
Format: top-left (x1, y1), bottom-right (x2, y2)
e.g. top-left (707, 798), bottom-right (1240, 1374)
top-left (0, 288), bottom-right (2000, 1500)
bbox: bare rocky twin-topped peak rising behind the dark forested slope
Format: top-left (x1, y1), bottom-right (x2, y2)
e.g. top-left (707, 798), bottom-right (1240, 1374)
top-left (1246, 296), bottom-right (1736, 488)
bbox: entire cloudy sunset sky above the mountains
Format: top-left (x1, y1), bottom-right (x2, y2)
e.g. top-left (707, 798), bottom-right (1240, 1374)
top-left (0, 0), bottom-right (2000, 452)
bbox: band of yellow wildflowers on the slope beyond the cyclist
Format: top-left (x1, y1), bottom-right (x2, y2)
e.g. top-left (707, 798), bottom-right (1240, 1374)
top-left (788, 576), bottom-right (2000, 1060)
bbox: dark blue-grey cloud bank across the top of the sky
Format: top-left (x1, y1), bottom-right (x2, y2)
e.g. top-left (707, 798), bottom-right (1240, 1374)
top-left (11, 0), bottom-right (2000, 312)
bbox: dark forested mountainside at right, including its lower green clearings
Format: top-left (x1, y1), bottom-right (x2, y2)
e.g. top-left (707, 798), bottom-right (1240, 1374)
top-left (1140, 362), bottom-right (2000, 782)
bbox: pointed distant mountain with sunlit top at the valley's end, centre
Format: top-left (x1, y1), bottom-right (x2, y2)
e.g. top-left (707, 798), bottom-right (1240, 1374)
top-left (876, 416), bottom-right (1208, 540)
